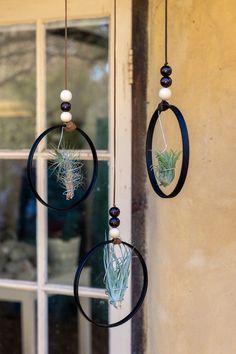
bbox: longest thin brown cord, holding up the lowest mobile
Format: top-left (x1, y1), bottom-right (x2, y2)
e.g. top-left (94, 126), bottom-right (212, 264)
top-left (113, 0), bottom-right (116, 206)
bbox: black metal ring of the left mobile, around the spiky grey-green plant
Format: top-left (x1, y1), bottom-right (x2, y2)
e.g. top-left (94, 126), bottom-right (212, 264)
top-left (27, 124), bottom-right (98, 211)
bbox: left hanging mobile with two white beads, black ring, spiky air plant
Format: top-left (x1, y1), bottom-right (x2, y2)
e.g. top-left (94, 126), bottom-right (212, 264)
top-left (27, 0), bottom-right (98, 211)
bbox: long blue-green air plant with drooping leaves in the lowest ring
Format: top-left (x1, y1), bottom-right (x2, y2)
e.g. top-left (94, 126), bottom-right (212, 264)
top-left (103, 236), bottom-right (132, 309)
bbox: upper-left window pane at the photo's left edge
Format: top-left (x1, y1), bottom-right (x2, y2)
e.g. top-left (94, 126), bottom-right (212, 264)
top-left (0, 25), bottom-right (36, 149)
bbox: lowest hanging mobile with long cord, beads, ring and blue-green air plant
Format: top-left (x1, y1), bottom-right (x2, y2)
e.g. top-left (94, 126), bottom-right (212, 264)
top-left (74, 0), bottom-right (148, 328)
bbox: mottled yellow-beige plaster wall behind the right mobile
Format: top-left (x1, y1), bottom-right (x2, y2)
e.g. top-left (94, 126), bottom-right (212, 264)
top-left (146, 0), bottom-right (236, 354)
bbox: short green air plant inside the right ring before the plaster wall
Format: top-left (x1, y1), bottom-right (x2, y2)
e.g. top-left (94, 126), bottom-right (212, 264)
top-left (153, 149), bottom-right (181, 187)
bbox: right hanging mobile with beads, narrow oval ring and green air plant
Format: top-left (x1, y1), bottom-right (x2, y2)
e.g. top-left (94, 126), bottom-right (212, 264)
top-left (146, 0), bottom-right (189, 198)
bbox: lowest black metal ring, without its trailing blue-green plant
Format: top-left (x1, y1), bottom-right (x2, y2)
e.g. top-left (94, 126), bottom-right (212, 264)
top-left (74, 240), bottom-right (148, 328)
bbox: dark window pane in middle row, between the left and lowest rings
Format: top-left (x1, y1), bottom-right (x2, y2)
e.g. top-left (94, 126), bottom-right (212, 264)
top-left (48, 161), bottom-right (108, 287)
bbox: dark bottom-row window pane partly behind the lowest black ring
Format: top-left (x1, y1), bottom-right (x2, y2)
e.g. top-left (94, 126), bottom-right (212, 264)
top-left (49, 295), bottom-right (108, 354)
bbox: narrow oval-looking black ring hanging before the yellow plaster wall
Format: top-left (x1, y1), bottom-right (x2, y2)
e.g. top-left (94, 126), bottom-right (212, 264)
top-left (146, 102), bottom-right (189, 198)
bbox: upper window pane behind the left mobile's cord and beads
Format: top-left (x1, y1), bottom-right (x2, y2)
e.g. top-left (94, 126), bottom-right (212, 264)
top-left (46, 20), bottom-right (109, 149)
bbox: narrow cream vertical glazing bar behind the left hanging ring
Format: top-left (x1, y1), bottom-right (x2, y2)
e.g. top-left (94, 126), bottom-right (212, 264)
top-left (36, 20), bottom-right (48, 354)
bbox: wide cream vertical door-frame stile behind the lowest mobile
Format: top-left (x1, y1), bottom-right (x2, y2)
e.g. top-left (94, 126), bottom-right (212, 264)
top-left (109, 0), bottom-right (132, 354)
